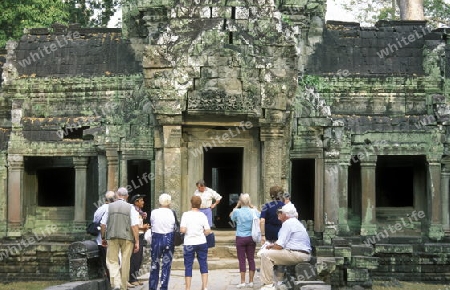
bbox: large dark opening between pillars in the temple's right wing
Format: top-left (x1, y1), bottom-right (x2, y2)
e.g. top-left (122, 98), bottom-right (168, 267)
top-left (376, 156), bottom-right (426, 207)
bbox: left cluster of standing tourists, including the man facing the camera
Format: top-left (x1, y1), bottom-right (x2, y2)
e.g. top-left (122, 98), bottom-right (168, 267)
top-left (94, 180), bottom-right (222, 290)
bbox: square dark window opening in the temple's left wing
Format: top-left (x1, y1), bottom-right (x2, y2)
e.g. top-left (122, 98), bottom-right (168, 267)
top-left (36, 167), bottom-right (75, 206)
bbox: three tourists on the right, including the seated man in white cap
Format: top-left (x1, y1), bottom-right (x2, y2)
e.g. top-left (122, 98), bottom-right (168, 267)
top-left (230, 186), bottom-right (312, 290)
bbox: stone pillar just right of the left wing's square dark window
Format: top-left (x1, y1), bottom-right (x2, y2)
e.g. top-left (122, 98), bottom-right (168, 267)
top-left (73, 157), bottom-right (88, 224)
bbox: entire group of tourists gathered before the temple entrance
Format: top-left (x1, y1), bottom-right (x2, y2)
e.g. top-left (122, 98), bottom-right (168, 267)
top-left (94, 180), bottom-right (311, 290)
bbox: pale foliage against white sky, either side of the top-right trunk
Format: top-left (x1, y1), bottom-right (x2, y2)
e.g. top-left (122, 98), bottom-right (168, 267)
top-left (342, 0), bottom-right (450, 27)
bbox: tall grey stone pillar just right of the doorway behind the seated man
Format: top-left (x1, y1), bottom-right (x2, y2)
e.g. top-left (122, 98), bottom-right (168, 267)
top-left (323, 159), bottom-right (339, 244)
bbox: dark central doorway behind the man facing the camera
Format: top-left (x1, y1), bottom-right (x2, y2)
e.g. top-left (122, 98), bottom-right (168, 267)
top-left (203, 147), bottom-right (244, 228)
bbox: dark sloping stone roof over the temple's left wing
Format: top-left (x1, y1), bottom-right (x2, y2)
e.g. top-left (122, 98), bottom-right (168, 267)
top-left (15, 25), bottom-right (142, 77)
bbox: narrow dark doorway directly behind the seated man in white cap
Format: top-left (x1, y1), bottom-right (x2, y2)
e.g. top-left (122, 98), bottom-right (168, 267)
top-left (291, 159), bottom-right (315, 220)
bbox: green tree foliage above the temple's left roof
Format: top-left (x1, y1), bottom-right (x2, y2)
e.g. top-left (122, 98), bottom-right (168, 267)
top-left (0, 0), bottom-right (120, 48)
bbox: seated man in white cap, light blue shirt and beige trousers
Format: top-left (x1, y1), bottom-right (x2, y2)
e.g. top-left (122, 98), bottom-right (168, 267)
top-left (260, 203), bottom-right (312, 290)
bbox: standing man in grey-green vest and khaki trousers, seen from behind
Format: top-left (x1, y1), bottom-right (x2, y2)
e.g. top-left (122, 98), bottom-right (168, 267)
top-left (100, 187), bottom-right (139, 290)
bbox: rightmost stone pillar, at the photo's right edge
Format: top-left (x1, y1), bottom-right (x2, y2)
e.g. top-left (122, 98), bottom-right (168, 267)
top-left (428, 161), bottom-right (444, 240)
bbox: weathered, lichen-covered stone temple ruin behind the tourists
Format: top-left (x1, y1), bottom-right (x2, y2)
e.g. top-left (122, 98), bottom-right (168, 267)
top-left (0, 0), bottom-right (450, 288)
